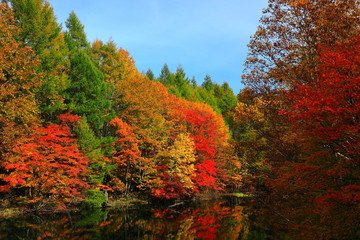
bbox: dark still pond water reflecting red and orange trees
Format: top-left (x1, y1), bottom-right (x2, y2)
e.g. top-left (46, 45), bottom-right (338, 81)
top-left (0, 197), bottom-right (360, 240)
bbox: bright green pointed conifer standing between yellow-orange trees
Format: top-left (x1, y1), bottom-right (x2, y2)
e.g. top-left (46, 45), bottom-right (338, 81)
top-left (65, 12), bottom-right (112, 137)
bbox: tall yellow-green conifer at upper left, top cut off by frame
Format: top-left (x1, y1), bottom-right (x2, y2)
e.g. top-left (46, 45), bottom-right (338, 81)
top-left (8, 0), bottom-right (69, 120)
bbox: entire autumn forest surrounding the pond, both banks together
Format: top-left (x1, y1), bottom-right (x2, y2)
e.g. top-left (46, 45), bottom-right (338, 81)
top-left (0, 0), bottom-right (360, 239)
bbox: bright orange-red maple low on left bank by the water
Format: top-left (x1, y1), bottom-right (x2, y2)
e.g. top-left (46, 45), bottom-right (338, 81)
top-left (0, 114), bottom-right (89, 207)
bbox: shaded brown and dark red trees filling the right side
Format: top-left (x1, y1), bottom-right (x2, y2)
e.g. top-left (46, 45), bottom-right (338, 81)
top-left (233, 0), bottom-right (360, 239)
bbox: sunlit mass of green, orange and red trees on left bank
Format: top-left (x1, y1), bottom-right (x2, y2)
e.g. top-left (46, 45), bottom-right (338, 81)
top-left (0, 0), bottom-right (241, 209)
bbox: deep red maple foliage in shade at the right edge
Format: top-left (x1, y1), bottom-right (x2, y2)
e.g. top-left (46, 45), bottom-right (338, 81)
top-left (270, 37), bottom-right (360, 234)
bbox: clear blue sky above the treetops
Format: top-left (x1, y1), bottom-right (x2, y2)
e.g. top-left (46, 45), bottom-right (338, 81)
top-left (49, 0), bottom-right (267, 94)
